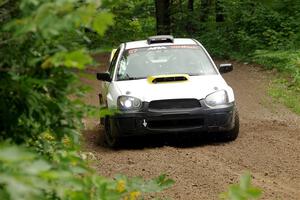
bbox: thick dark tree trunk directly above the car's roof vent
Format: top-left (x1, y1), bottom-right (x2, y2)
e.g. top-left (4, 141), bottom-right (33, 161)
top-left (155, 0), bottom-right (171, 35)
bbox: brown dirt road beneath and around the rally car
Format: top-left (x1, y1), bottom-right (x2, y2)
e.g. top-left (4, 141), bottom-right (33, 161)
top-left (82, 55), bottom-right (300, 200)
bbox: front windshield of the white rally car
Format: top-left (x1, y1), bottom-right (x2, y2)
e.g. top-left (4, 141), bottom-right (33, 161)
top-left (117, 45), bottom-right (217, 80)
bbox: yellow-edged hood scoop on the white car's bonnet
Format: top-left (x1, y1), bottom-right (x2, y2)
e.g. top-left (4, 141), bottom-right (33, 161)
top-left (148, 74), bottom-right (189, 84)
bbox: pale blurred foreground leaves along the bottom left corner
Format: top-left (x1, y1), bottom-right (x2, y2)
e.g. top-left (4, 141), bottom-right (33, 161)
top-left (0, 145), bottom-right (173, 200)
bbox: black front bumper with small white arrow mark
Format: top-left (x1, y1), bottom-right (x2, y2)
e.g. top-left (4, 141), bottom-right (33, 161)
top-left (110, 103), bottom-right (236, 136)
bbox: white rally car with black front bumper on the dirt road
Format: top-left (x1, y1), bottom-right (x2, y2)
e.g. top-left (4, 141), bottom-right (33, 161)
top-left (97, 36), bottom-right (239, 147)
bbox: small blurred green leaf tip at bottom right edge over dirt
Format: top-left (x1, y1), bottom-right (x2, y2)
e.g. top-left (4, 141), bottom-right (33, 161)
top-left (220, 173), bottom-right (262, 200)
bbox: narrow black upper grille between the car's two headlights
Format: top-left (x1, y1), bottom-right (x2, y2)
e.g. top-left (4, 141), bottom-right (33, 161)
top-left (149, 99), bottom-right (201, 110)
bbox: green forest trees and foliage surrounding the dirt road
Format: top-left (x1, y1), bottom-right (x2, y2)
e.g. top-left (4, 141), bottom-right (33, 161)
top-left (0, 0), bottom-right (300, 200)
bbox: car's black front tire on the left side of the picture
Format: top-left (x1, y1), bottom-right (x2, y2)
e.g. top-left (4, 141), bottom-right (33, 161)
top-left (104, 117), bottom-right (120, 148)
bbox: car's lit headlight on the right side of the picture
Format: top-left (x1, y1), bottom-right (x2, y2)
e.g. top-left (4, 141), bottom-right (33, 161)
top-left (205, 90), bottom-right (229, 107)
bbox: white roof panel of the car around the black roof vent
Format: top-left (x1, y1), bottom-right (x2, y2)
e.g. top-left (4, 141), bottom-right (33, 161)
top-left (124, 38), bottom-right (198, 49)
